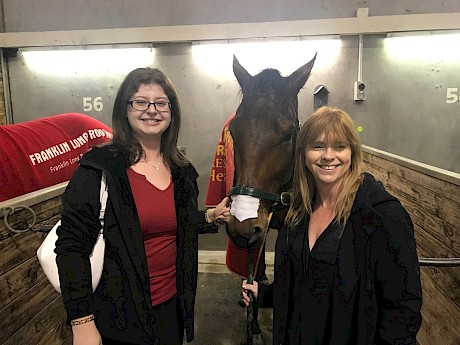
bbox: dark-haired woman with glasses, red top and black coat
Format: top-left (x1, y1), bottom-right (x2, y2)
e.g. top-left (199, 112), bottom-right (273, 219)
top-left (56, 68), bottom-right (229, 345)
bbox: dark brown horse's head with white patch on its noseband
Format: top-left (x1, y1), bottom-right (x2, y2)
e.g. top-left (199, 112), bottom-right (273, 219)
top-left (227, 55), bottom-right (316, 248)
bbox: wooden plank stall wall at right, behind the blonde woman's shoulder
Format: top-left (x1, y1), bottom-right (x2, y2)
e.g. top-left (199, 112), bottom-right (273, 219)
top-left (364, 149), bottom-right (460, 345)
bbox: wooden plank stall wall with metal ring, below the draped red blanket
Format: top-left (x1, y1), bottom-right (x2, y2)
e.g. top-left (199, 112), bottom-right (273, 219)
top-left (0, 188), bottom-right (72, 345)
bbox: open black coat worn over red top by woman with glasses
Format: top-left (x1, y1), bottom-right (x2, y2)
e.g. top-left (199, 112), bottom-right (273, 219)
top-left (56, 146), bottom-right (217, 344)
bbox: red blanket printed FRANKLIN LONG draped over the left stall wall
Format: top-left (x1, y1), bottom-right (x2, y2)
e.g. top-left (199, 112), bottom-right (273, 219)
top-left (0, 113), bottom-right (112, 201)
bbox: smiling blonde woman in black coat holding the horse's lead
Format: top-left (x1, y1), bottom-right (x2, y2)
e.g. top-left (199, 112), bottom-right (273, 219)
top-left (243, 107), bottom-right (422, 345)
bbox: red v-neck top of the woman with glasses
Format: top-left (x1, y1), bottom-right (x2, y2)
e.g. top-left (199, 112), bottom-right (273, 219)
top-left (128, 168), bottom-right (177, 306)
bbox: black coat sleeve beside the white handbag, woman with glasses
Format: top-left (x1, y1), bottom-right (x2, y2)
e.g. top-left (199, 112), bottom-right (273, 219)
top-left (55, 166), bottom-right (102, 321)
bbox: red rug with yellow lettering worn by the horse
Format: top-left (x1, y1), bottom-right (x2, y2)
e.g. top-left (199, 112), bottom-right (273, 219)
top-left (205, 114), bottom-right (259, 278)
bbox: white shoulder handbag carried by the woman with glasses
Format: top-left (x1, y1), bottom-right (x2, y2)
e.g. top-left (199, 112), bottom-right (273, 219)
top-left (37, 172), bottom-right (108, 293)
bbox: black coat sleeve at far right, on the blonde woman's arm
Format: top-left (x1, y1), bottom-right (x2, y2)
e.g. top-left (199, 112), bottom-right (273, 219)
top-left (373, 202), bottom-right (422, 344)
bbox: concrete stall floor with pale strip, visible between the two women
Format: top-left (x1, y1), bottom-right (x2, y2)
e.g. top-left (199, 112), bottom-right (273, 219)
top-left (192, 227), bottom-right (276, 345)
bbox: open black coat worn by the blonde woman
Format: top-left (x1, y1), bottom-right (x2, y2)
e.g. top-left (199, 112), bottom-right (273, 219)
top-left (259, 174), bottom-right (422, 345)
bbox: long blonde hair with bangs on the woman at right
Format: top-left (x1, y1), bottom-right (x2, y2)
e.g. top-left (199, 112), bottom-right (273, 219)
top-left (285, 107), bottom-right (363, 226)
